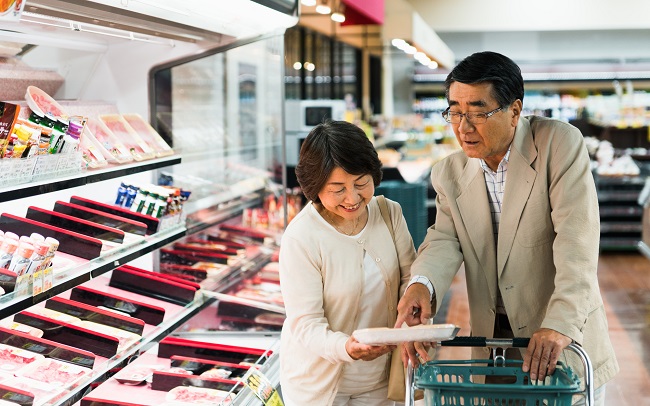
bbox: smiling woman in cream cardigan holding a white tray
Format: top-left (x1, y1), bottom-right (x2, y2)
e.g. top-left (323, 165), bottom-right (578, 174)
top-left (280, 121), bottom-right (415, 406)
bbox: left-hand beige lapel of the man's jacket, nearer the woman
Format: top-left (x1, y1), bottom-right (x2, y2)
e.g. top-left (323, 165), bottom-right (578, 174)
top-left (456, 159), bottom-right (497, 297)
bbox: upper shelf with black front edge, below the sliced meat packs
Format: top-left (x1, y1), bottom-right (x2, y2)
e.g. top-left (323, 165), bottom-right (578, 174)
top-left (0, 155), bottom-right (181, 202)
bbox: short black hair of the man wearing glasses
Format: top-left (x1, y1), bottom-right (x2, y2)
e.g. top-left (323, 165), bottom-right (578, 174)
top-left (445, 51), bottom-right (524, 107)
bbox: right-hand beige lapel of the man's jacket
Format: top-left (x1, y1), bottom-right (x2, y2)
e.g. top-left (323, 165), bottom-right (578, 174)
top-left (497, 117), bottom-right (537, 275)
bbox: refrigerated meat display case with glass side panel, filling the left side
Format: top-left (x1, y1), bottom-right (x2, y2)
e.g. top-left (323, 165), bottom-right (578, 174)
top-left (0, 0), bottom-right (298, 404)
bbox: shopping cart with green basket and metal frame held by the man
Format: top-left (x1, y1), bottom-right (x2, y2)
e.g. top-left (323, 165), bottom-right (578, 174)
top-left (404, 337), bottom-right (594, 406)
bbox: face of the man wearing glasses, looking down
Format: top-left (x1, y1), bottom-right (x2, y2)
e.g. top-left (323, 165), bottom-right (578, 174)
top-left (449, 82), bottom-right (522, 170)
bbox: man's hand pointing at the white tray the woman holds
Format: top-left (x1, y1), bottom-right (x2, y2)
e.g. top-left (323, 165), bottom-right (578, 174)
top-left (395, 283), bottom-right (431, 366)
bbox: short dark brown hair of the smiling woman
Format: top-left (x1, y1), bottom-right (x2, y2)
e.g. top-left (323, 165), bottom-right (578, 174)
top-left (296, 121), bottom-right (382, 203)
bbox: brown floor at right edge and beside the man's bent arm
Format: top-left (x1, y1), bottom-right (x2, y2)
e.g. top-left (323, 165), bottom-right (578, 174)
top-left (438, 253), bottom-right (650, 406)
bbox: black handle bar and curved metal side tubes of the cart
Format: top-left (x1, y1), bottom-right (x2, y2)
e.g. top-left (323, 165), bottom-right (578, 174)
top-left (404, 337), bottom-right (594, 406)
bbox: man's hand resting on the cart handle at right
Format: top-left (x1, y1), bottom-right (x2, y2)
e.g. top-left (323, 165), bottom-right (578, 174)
top-left (522, 328), bottom-right (572, 381)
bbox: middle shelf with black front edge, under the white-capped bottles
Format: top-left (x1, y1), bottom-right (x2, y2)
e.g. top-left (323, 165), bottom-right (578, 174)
top-left (0, 226), bottom-right (186, 319)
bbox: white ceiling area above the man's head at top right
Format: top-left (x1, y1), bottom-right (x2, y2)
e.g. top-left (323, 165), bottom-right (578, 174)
top-left (408, 0), bottom-right (650, 72)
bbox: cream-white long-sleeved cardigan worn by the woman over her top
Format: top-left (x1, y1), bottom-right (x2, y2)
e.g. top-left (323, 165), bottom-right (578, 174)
top-left (280, 198), bottom-right (415, 406)
